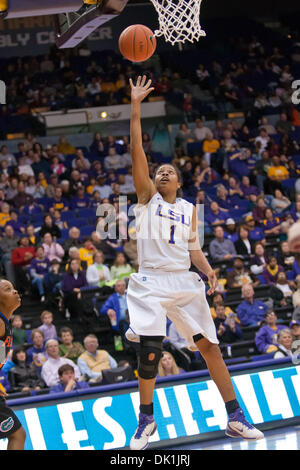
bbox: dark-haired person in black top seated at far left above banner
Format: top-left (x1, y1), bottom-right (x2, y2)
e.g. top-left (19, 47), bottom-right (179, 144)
top-left (8, 346), bottom-right (45, 393)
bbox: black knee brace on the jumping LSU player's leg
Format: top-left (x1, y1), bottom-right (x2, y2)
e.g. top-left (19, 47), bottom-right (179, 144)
top-left (138, 336), bottom-right (163, 379)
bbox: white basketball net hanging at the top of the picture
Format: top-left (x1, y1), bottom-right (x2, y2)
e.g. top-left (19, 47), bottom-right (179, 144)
top-left (151, 0), bottom-right (206, 45)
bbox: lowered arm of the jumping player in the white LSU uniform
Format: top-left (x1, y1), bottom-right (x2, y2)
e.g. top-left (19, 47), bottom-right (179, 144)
top-left (189, 207), bottom-right (218, 295)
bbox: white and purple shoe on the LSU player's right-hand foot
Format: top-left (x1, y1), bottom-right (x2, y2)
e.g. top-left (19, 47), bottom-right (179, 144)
top-left (225, 408), bottom-right (264, 441)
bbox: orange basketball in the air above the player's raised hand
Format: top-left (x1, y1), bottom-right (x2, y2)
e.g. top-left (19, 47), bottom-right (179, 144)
top-left (119, 24), bottom-right (156, 62)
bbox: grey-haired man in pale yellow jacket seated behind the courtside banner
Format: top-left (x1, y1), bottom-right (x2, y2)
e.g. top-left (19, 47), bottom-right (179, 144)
top-left (77, 334), bottom-right (117, 382)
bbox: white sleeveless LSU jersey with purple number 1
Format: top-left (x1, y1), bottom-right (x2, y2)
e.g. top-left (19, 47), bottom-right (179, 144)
top-left (135, 193), bottom-right (193, 271)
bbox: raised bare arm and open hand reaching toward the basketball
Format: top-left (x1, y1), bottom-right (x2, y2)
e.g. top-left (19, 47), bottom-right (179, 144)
top-left (129, 75), bottom-right (156, 204)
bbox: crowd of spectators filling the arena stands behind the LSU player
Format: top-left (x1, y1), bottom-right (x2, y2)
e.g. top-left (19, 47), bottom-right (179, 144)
top-left (0, 23), bottom-right (300, 393)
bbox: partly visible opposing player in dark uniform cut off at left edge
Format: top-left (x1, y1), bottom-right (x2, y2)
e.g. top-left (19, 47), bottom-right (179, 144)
top-left (0, 279), bottom-right (26, 450)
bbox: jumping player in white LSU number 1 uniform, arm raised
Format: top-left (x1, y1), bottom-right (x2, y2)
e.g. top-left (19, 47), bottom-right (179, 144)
top-left (126, 76), bottom-right (263, 450)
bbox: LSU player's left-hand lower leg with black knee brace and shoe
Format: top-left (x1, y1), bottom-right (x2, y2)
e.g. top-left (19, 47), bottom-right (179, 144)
top-left (130, 336), bottom-right (164, 450)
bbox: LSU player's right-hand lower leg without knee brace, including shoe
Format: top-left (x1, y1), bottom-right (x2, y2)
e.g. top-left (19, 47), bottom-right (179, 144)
top-left (194, 334), bottom-right (264, 441)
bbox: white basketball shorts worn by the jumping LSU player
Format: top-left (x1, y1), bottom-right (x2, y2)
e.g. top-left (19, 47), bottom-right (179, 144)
top-left (126, 270), bottom-right (219, 350)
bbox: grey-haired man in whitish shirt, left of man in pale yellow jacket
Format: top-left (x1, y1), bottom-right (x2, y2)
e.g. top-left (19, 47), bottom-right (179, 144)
top-left (41, 339), bottom-right (81, 387)
